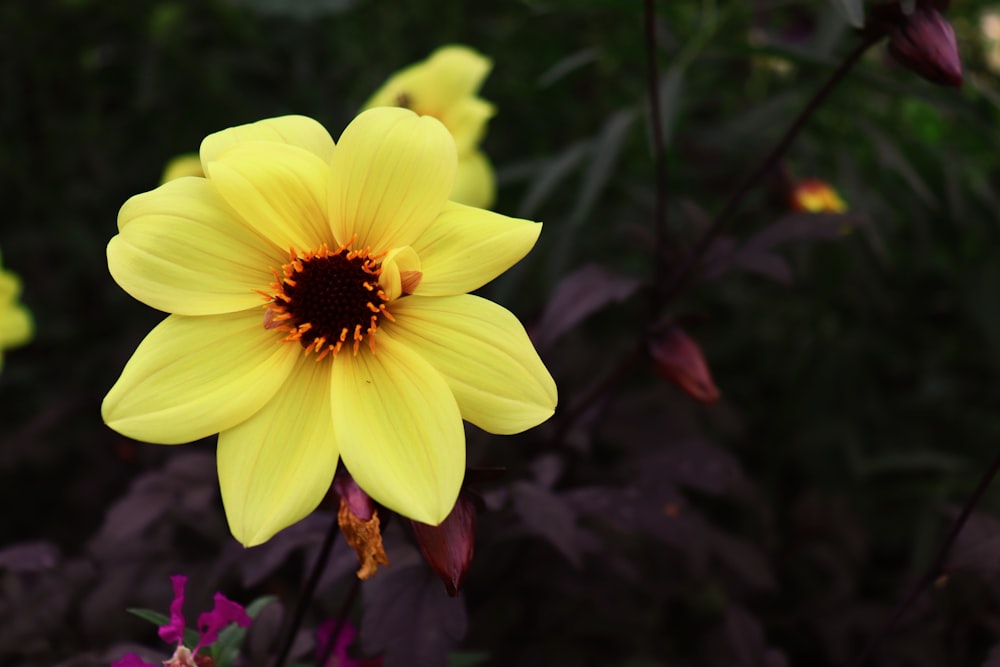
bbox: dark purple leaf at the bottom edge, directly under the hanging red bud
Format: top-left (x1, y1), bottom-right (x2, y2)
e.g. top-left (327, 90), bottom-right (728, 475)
top-left (361, 530), bottom-right (468, 667)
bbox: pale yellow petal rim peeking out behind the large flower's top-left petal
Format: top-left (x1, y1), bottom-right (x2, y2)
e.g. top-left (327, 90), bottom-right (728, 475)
top-left (200, 116), bottom-right (333, 171)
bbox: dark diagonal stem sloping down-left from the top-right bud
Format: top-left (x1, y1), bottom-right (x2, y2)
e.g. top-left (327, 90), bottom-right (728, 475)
top-left (660, 34), bottom-right (883, 304)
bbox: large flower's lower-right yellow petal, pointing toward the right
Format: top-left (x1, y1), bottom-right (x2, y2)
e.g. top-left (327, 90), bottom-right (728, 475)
top-left (378, 294), bottom-right (557, 434)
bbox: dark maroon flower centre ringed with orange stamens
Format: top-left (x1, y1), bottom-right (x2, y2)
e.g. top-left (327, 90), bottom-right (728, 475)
top-left (261, 244), bottom-right (393, 361)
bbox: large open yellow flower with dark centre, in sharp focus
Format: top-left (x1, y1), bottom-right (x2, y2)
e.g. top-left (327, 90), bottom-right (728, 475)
top-left (102, 108), bottom-right (556, 545)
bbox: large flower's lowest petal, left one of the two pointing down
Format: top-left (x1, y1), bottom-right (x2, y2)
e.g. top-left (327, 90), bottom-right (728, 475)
top-left (218, 355), bottom-right (337, 547)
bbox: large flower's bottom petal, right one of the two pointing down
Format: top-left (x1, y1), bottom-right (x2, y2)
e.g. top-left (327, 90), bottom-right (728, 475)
top-left (331, 334), bottom-right (465, 525)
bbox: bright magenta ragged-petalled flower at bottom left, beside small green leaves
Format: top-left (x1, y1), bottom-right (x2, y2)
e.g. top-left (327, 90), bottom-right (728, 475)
top-left (111, 574), bottom-right (253, 667)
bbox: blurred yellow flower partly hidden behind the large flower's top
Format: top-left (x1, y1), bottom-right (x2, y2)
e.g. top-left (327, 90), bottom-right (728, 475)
top-left (364, 46), bottom-right (496, 208)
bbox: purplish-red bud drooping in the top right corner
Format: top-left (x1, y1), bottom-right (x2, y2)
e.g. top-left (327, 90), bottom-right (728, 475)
top-left (889, 7), bottom-right (962, 88)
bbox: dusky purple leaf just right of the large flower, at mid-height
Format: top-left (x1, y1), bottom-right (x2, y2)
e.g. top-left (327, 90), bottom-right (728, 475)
top-left (532, 264), bottom-right (639, 347)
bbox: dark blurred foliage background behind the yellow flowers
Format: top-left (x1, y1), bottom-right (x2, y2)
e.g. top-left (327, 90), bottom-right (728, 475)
top-left (0, 0), bottom-right (1000, 667)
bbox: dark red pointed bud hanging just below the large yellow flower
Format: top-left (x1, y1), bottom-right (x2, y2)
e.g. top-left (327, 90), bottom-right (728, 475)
top-left (410, 492), bottom-right (476, 597)
